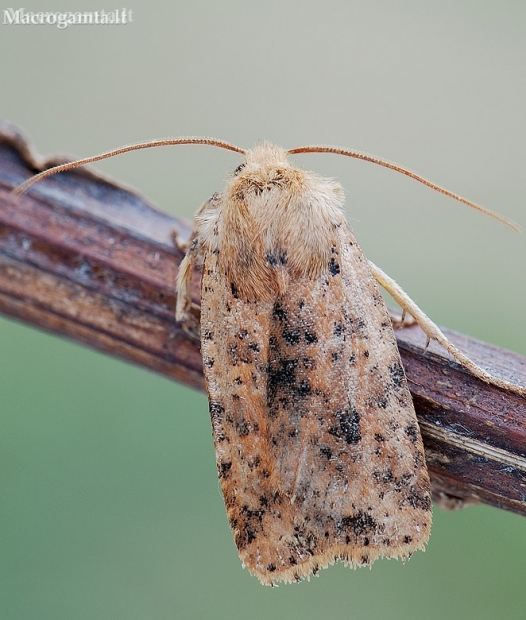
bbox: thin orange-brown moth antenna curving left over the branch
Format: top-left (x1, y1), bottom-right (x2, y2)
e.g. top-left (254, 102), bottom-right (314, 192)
top-left (12, 137), bottom-right (246, 197)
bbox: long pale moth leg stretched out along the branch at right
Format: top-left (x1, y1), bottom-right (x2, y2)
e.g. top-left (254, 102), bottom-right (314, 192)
top-left (369, 261), bottom-right (526, 395)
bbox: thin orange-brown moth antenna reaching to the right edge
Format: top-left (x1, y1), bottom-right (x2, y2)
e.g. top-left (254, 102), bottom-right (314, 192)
top-left (287, 146), bottom-right (521, 233)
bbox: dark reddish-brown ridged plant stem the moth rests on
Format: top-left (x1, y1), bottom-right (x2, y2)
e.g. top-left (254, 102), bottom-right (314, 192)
top-left (0, 122), bottom-right (526, 515)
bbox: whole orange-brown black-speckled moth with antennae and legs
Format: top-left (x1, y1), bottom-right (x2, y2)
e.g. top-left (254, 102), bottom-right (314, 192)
top-left (18, 138), bottom-right (524, 585)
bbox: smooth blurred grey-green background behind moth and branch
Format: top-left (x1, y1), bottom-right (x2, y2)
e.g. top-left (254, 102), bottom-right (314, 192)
top-left (0, 0), bottom-right (526, 620)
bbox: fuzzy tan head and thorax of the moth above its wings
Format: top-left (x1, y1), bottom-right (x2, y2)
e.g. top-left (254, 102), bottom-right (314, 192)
top-left (197, 143), bottom-right (344, 299)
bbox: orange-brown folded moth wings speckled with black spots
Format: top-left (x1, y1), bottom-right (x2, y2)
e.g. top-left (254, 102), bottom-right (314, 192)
top-left (201, 223), bottom-right (431, 584)
